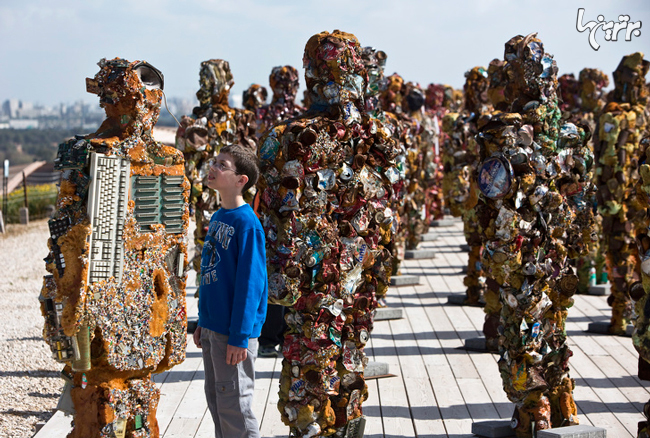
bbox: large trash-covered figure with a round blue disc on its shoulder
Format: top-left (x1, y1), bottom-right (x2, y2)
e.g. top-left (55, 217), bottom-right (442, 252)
top-left (476, 34), bottom-right (593, 437)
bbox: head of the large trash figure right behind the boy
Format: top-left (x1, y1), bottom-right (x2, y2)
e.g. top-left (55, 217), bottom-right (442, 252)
top-left (303, 30), bottom-right (368, 108)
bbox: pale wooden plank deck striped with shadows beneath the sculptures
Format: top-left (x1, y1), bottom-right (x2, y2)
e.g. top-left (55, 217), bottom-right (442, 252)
top-left (36, 217), bottom-right (650, 438)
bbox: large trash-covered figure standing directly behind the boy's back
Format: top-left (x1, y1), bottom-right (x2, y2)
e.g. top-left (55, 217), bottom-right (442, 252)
top-left (258, 31), bottom-right (400, 437)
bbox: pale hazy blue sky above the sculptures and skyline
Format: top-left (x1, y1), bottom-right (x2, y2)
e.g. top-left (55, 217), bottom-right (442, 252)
top-left (0, 0), bottom-right (650, 109)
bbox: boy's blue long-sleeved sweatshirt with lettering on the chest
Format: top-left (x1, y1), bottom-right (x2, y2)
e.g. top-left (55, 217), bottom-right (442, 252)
top-left (199, 204), bottom-right (268, 348)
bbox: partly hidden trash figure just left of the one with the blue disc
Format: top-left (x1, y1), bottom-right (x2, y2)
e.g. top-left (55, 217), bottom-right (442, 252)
top-left (442, 67), bottom-right (492, 306)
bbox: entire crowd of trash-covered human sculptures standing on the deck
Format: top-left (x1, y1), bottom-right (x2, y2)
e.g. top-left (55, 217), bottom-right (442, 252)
top-left (40, 30), bottom-right (650, 438)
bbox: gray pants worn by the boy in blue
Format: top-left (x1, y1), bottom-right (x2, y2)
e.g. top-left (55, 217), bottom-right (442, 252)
top-left (201, 327), bottom-right (260, 438)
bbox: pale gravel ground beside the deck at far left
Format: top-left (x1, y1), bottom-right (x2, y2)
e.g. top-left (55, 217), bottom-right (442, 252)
top-left (0, 220), bottom-right (63, 438)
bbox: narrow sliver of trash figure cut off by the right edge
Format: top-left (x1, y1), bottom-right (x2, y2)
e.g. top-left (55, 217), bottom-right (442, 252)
top-left (630, 131), bottom-right (650, 437)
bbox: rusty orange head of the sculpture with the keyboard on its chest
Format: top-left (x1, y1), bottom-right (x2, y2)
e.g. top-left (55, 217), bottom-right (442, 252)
top-left (86, 58), bottom-right (164, 131)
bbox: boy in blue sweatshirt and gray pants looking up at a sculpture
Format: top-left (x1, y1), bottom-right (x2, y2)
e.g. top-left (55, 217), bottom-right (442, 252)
top-left (194, 145), bottom-right (268, 438)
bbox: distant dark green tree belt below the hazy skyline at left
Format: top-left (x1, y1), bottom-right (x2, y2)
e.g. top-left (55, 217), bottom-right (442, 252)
top-left (0, 129), bottom-right (79, 166)
